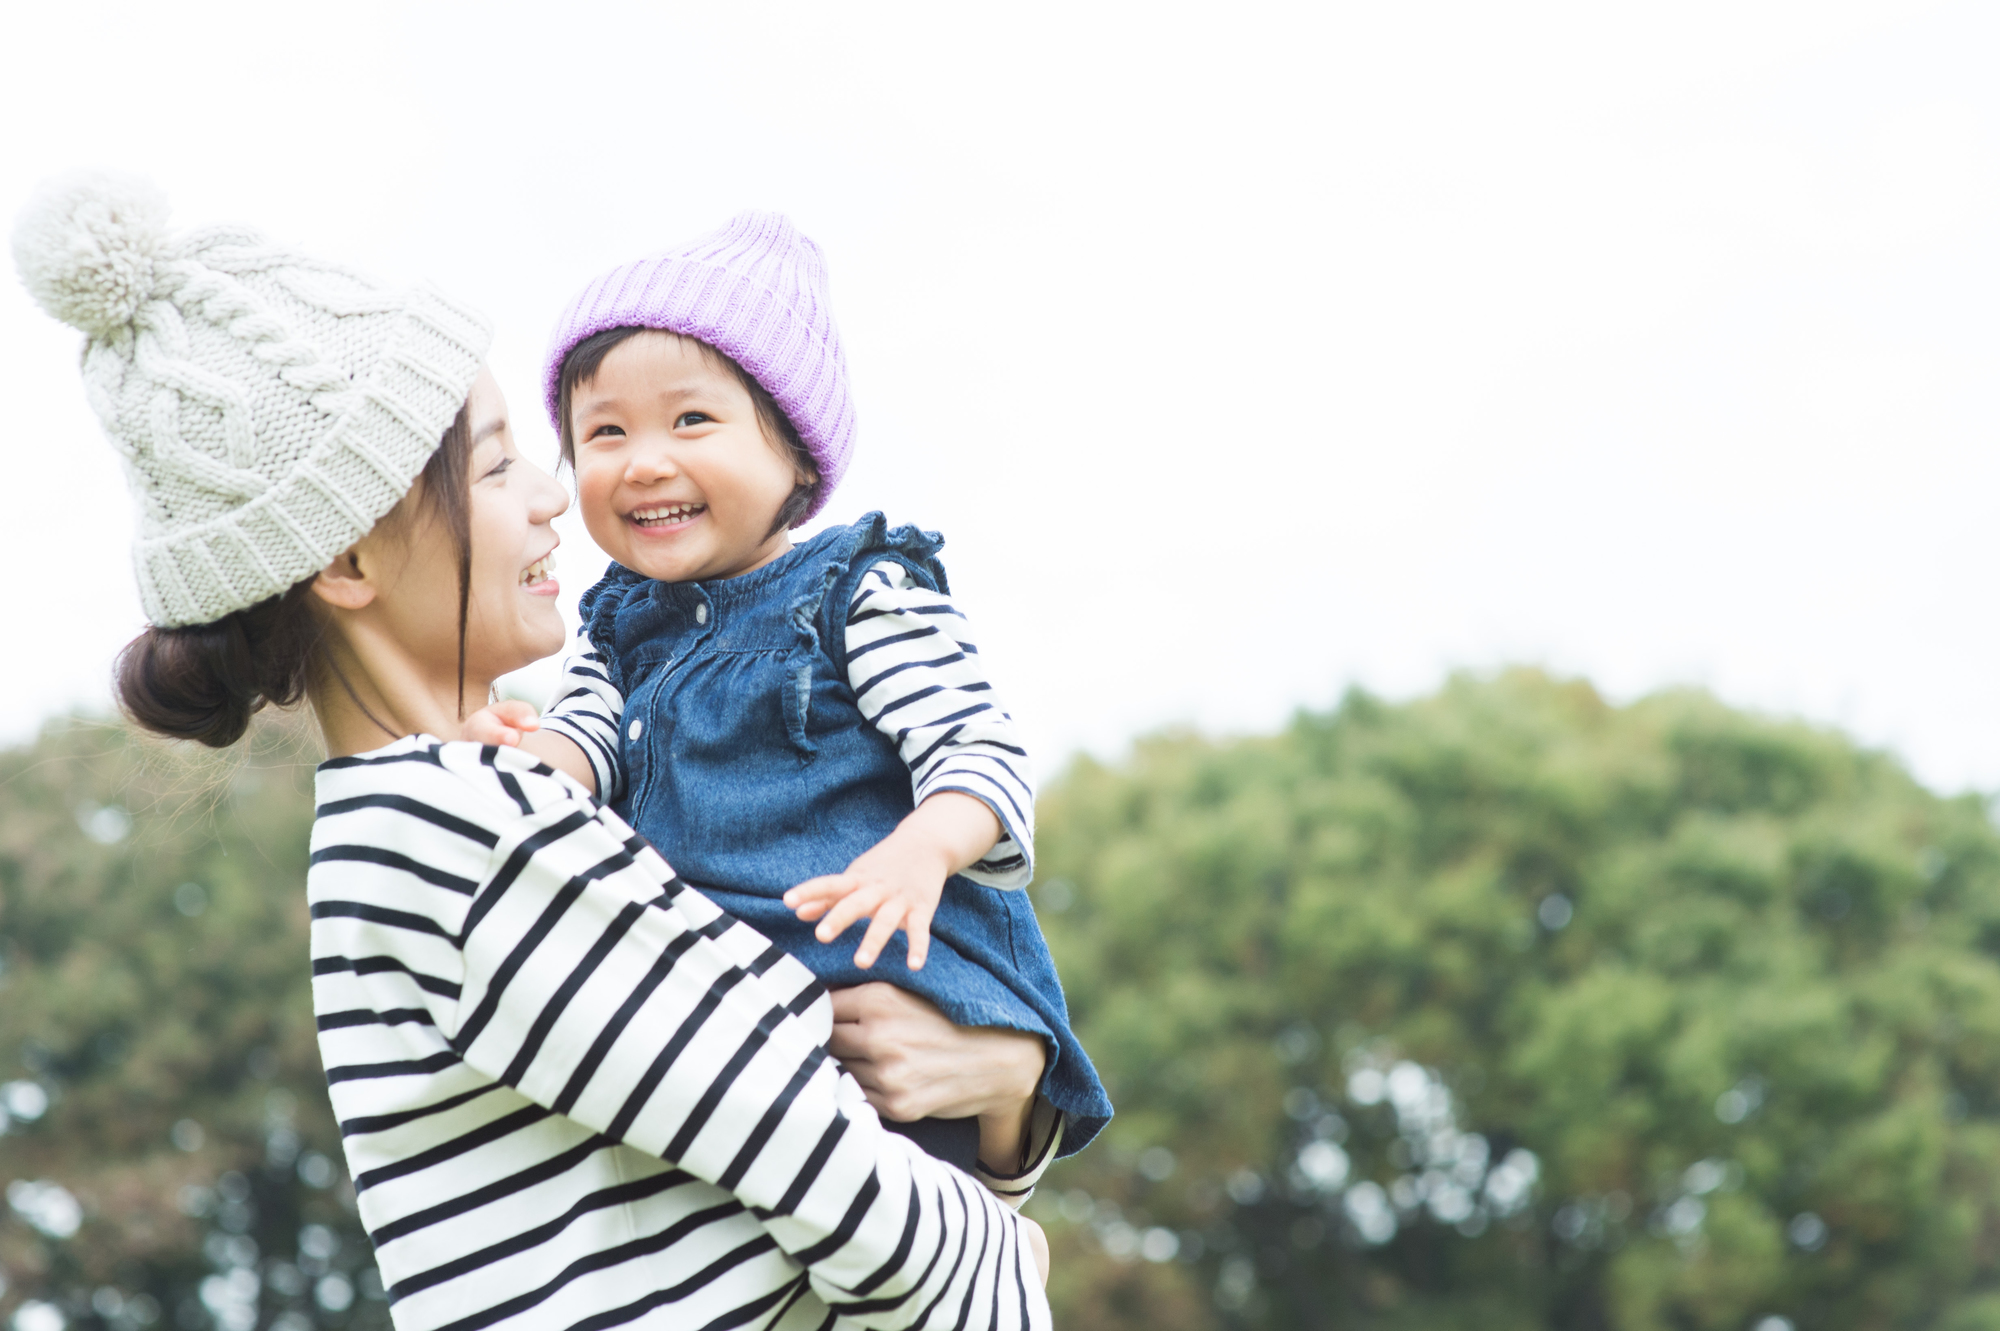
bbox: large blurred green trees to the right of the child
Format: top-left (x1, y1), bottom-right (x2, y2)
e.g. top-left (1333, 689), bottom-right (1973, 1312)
top-left (1030, 671), bottom-right (2000, 1331)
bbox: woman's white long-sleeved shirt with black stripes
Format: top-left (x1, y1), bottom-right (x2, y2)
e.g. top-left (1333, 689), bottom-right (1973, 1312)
top-left (308, 735), bottom-right (1052, 1331)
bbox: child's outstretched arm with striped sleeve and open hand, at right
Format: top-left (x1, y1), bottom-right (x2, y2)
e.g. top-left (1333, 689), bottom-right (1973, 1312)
top-left (784, 562), bottom-right (1034, 971)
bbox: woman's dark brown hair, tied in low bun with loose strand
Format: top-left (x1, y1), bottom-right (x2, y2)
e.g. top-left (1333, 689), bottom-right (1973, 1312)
top-left (112, 404), bottom-right (472, 749)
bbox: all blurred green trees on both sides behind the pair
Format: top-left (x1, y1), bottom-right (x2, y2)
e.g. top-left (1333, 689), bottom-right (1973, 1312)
top-left (11, 671), bottom-right (2000, 1331)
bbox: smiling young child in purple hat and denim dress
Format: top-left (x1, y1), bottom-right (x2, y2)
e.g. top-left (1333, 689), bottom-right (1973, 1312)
top-left (482, 214), bottom-right (1112, 1191)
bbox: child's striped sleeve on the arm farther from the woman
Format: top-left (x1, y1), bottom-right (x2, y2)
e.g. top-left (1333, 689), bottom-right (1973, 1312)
top-left (846, 560), bottom-right (1034, 889)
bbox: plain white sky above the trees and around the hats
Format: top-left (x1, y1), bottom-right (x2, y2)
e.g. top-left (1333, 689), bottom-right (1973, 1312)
top-left (0, 0), bottom-right (2000, 787)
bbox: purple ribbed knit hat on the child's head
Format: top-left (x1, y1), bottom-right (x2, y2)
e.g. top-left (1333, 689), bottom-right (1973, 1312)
top-left (542, 212), bottom-right (854, 522)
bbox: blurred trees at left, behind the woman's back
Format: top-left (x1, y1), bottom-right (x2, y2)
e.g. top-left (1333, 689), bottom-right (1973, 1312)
top-left (0, 721), bottom-right (388, 1331)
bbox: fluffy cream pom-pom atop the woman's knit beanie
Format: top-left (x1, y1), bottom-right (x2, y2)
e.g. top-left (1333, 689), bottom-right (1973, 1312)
top-left (14, 174), bottom-right (168, 338)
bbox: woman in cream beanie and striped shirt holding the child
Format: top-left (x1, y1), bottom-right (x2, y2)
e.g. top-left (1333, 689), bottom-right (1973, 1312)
top-left (14, 178), bottom-right (1054, 1331)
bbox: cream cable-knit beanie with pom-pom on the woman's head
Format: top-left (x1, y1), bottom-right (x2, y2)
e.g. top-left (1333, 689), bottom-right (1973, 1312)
top-left (14, 176), bottom-right (492, 628)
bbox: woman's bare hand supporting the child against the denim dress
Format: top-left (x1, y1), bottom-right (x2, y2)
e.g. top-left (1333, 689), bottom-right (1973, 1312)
top-left (828, 983), bottom-right (1048, 1173)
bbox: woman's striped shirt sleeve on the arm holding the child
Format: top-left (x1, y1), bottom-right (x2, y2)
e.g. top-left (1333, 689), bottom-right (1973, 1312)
top-left (398, 745), bottom-right (1048, 1327)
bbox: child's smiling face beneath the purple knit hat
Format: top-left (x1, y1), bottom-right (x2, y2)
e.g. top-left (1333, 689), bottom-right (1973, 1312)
top-left (570, 332), bottom-right (808, 582)
